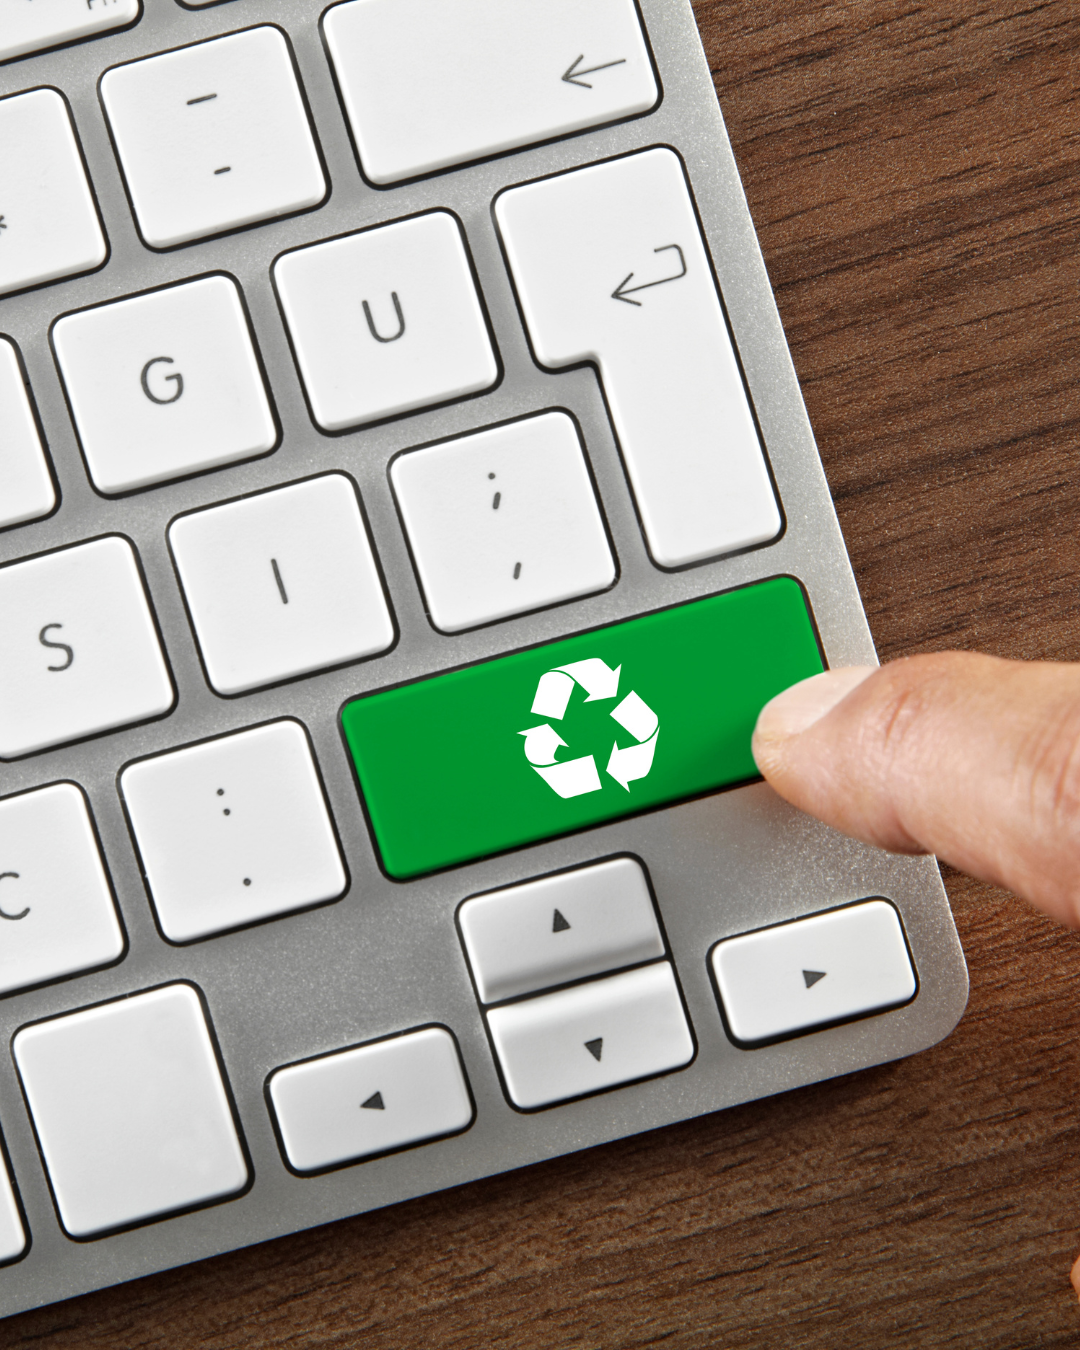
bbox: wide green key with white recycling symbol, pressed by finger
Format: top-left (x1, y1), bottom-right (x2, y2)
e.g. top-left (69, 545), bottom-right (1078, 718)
top-left (342, 576), bottom-right (824, 878)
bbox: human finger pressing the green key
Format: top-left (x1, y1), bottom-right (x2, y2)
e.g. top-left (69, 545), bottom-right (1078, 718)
top-left (753, 652), bottom-right (1080, 927)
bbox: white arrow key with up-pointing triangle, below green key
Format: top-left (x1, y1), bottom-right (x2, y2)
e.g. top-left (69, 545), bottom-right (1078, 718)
top-left (458, 857), bottom-right (664, 1003)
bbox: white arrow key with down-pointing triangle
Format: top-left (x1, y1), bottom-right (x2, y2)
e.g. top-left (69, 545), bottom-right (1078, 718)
top-left (487, 961), bottom-right (694, 1110)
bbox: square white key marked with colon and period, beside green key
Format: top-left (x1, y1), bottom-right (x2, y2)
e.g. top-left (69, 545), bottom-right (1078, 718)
top-left (120, 721), bottom-right (347, 942)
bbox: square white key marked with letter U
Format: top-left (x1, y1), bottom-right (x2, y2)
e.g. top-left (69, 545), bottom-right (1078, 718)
top-left (274, 211), bottom-right (498, 431)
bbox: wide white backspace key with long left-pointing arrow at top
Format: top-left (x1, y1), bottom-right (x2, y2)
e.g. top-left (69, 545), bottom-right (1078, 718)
top-left (323, 0), bottom-right (659, 184)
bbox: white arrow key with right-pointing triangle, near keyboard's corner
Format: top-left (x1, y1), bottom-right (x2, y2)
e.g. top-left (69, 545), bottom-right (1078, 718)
top-left (711, 900), bottom-right (915, 1046)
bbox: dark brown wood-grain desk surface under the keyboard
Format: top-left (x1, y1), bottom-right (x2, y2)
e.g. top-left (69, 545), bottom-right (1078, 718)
top-left (8, 0), bottom-right (1080, 1350)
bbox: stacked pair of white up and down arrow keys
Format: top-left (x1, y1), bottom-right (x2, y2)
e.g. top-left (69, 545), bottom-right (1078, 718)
top-left (458, 857), bottom-right (694, 1110)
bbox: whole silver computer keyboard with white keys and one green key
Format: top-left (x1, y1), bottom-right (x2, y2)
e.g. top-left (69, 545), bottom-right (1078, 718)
top-left (0, 0), bottom-right (967, 1314)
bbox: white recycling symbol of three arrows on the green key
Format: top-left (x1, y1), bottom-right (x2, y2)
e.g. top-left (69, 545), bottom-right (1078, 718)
top-left (517, 656), bottom-right (660, 797)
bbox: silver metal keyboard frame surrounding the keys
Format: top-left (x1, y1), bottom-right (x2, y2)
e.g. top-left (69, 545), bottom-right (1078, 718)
top-left (0, 0), bottom-right (968, 1315)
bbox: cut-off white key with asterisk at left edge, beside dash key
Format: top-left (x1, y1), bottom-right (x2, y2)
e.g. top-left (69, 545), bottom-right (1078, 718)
top-left (0, 91), bottom-right (108, 296)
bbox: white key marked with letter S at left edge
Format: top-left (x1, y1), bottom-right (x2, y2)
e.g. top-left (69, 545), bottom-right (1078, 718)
top-left (0, 535), bottom-right (174, 759)
